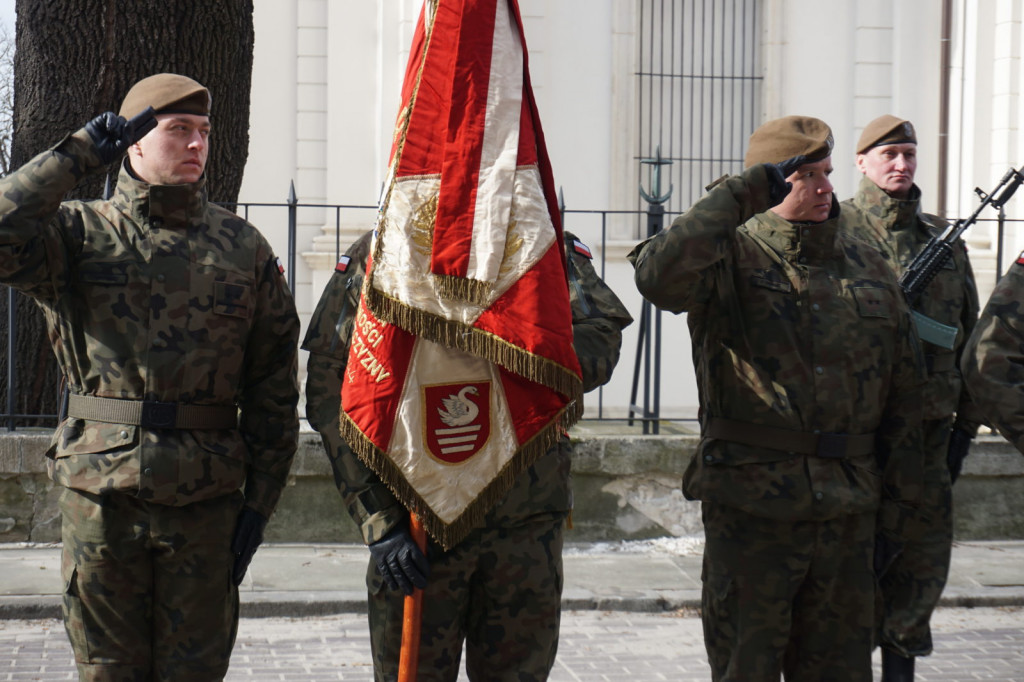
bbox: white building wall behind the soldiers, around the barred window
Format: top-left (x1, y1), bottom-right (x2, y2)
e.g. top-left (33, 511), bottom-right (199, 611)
top-left (240, 0), bottom-right (1024, 416)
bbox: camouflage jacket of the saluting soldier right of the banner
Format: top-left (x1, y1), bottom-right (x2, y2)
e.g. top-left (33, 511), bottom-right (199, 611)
top-left (630, 166), bottom-right (925, 535)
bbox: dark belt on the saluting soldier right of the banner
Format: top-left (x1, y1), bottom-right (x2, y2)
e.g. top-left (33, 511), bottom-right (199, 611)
top-left (705, 417), bottom-right (874, 459)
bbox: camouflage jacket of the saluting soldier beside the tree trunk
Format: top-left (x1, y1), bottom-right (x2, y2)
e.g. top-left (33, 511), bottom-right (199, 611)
top-left (0, 130), bottom-right (299, 517)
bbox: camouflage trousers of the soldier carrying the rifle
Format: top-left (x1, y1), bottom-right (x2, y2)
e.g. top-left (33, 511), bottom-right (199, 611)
top-left (877, 419), bottom-right (953, 656)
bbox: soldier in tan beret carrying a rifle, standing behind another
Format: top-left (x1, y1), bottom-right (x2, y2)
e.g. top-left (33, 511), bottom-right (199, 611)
top-left (844, 115), bottom-right (984, 682)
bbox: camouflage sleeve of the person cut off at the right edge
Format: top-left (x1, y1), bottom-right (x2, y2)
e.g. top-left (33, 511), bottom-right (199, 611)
top-left (961, 258), bottom-right (1024, 454)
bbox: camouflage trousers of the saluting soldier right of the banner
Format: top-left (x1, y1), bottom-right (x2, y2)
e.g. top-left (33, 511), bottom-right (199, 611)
top-left (701, 502), bottom-right (874, 682)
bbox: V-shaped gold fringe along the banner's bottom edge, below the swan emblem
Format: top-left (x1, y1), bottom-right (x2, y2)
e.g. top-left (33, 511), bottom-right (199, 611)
top-left (339, 400), bottom-right (583, 551)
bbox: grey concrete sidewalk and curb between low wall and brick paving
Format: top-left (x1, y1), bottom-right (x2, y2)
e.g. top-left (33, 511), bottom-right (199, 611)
top-left (0, 539), bottom-right (1024, 620)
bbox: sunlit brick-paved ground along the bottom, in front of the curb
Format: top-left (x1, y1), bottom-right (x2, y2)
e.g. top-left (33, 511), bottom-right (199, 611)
top-left (0, 607), bottom-right (1024, 682)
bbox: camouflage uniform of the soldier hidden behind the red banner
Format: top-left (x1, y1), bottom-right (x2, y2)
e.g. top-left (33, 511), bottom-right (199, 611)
top-left (302, 227), bottom-right (632, 681)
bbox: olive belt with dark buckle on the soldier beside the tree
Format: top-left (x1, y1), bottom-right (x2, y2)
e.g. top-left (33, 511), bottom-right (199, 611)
top-left (68, 395), bottom-right (239, 429)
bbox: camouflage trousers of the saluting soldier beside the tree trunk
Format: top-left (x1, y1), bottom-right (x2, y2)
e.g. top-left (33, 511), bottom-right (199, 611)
top-left (60, 488), bottom-right (243, 682)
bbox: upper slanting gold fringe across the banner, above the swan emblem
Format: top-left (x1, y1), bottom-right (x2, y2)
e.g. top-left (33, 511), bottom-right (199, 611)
top-left (362, 280), bottom-right (583, 400)
